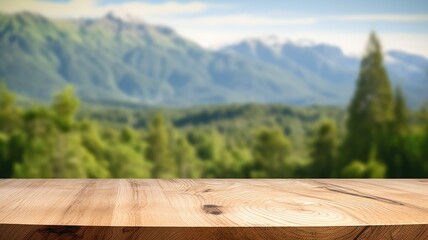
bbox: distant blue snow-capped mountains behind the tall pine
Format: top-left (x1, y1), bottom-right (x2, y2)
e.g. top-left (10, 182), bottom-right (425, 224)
top-left (220, 37), bottom-right (428, 106)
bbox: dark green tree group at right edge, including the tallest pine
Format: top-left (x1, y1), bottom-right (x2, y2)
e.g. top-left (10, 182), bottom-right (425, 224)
top-left (338, 33), bottom-right (427, 178)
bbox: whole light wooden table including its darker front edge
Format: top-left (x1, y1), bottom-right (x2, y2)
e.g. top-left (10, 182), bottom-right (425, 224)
top-left (0, 179), bottom-right (428, 240)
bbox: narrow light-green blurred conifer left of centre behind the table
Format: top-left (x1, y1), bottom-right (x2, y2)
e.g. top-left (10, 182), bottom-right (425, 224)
top-left (146, 114), bottom-right (177, 178)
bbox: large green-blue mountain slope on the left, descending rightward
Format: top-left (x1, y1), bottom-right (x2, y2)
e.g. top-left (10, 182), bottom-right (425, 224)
top-left (0, 13), bottom-right (328, 105)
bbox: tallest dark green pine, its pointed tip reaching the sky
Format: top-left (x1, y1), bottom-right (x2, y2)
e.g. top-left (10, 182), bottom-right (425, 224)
top-left (342, 33), bottom-right (394, 166)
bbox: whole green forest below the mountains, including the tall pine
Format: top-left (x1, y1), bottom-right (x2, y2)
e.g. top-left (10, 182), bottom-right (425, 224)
top-left (0, 34), bottom-right (428, 178)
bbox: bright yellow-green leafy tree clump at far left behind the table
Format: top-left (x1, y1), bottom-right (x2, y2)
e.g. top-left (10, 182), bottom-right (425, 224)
top-left (2, 89), bottom-right (109, 178)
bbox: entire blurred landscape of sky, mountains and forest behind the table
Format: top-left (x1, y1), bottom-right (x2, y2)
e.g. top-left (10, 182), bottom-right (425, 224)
top-left (0, 0), bottom-right (428, 178)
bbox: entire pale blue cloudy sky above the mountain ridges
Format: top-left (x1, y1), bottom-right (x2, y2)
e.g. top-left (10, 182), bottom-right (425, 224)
top-left (0, 0), bottom-right (428, 57)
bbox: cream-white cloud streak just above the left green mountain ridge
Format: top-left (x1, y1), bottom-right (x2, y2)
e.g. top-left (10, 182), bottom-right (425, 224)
top-left (0, 0), bottom-right (316, 27)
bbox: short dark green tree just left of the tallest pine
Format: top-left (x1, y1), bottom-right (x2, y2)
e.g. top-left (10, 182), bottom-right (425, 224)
top-left (310, 121), bottom-right (337, 178)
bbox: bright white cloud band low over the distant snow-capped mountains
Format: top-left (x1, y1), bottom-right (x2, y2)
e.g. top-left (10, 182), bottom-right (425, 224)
top-left (179, 29), bottom-right (428, 57)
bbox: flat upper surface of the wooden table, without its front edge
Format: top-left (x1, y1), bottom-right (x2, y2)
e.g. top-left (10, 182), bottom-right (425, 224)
top-left (0, 179), bottom-right (428, 238)
